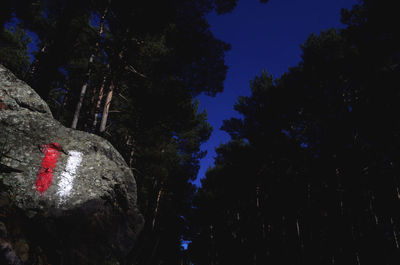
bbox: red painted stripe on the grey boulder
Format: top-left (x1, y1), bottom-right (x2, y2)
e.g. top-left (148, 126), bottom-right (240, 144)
top-left (36, 143), bottom-right (61, 194)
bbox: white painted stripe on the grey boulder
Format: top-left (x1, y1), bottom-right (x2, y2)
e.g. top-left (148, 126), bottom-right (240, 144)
top-left (57, 151), bottom-right (82, 203)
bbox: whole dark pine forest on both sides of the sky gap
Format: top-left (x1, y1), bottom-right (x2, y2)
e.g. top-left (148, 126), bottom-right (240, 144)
top-left (0, 0), bottom-right (400, 265)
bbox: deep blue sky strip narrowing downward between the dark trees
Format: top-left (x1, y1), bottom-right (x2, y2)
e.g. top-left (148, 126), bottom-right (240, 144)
top-left (195, 0), bottom-right (357, 185)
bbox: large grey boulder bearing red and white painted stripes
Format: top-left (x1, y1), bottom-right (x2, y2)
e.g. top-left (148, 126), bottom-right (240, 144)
top-left (0, 65), bottom-right (143, 264)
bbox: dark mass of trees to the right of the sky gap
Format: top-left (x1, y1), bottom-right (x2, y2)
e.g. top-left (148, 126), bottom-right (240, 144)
top-left (189, 0), bottom-right (400, 265)
